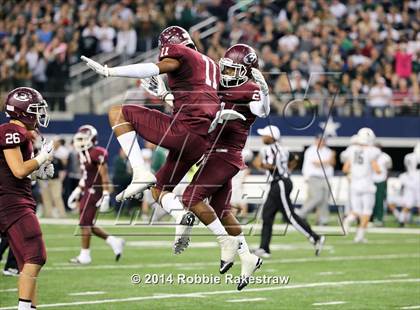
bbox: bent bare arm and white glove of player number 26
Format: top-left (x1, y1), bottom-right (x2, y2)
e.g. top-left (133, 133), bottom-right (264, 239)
top-left (3, 141), bottom-right (54, 179)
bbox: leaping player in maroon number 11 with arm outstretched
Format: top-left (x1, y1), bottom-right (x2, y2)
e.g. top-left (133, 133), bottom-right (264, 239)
top-left (82, 26), bottom-right (220, 237)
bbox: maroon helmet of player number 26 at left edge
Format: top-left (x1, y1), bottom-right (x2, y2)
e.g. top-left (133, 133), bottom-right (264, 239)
top-left (5, 87), bottom-right (50, 130)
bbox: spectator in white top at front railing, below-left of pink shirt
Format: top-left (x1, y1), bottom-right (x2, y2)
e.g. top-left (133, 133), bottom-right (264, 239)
top-left (367, 77), bottom-right (392, 116)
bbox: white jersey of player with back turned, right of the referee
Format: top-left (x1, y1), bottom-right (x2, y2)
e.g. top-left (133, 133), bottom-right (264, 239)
top-left (347, 145), bottom-right (381, 192)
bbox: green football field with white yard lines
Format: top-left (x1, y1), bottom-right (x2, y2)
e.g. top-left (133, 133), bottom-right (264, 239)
top-left (0, 224), bottom-right (420, 309)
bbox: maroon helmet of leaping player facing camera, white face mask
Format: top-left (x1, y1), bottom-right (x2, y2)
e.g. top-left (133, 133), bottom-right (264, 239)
top-left (219, 44), bottom-right (258, 87)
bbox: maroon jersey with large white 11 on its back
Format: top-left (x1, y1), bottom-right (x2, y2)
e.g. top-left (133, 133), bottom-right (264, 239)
top-left (159, 44), bottom-right (220, 135)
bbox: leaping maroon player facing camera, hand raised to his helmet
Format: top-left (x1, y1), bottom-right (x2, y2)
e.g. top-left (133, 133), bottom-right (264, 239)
top-left (143, 44), bottom-right (270, 290)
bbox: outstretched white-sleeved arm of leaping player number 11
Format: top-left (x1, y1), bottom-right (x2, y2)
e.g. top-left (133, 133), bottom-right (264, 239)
top-left (81, 56), bottom-right (181, 79)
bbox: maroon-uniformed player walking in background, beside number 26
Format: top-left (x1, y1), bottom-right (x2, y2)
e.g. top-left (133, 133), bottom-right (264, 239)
top-left (67, 125), bottom-right (125, 265)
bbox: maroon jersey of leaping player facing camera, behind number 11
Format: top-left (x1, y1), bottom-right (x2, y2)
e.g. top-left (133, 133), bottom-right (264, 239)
top-left (212, 81), bottom-right (260, 169)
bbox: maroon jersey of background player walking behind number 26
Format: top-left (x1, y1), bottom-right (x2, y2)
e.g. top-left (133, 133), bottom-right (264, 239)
top-left (79, 146), bottom-right (108, 193)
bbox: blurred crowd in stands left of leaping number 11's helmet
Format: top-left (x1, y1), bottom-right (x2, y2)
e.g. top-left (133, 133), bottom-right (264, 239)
top-left (0, 0), bottom-right (217, 111)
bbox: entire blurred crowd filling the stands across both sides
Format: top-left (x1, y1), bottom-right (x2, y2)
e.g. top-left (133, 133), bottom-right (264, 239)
top-left (0, 0), bottom-right (420, 116)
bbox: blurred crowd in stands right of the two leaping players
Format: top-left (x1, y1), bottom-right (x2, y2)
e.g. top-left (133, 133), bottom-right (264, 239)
top-left (194, 0), bottom-right (420, 116)
